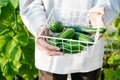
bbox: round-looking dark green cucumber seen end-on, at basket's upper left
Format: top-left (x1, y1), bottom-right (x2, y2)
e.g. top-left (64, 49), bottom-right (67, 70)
top-left (50, 21), bottom-right (64, 33)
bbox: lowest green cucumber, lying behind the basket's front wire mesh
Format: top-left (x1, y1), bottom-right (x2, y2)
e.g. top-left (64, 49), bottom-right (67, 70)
top-left (58, 41), bottom-right (84, 54)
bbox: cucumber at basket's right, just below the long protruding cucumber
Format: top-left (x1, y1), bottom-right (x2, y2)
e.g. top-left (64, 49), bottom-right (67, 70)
top-left (73, 32), bottom-right (94, 45)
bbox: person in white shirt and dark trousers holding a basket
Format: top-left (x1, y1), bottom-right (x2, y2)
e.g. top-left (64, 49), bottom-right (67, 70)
top-left (20, 0), bottom-right (120, 80)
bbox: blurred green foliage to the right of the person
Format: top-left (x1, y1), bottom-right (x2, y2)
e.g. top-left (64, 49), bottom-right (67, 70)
top-left (99, 15), bottom-right (120, 80)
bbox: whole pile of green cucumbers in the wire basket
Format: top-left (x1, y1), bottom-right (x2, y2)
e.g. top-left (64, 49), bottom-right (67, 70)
top-left (49, 21), bottom-right (106, 54)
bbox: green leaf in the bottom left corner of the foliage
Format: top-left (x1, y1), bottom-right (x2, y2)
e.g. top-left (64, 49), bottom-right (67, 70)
top-left (0, 53), bottom-right (18, 80)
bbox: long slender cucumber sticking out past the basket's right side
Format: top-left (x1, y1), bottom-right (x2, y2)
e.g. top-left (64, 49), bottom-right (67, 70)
top-left (64, 26), bottom-right (106, 34)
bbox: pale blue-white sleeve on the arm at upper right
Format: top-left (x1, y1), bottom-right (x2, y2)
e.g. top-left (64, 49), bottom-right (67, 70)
top-left (95, 0), bottom-right (120, 25)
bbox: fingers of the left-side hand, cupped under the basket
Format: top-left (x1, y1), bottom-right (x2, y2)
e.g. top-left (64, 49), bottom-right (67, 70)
top-left (37, 39), bottom-right (63, 56)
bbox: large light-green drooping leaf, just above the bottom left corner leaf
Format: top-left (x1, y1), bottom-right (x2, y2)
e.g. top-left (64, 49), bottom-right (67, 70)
top-left (5, 40), bottom-right (22, 69)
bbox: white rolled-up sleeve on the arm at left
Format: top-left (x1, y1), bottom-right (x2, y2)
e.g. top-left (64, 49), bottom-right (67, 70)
top-left (20, 0), bottom-right (47, 36)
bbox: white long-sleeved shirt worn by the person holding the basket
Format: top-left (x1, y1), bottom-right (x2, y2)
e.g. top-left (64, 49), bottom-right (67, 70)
top-left (20, 0), bottom-right (120, 74)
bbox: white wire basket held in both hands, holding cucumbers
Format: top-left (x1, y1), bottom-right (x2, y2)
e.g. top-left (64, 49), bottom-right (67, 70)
top-left (39, 8), bottom-right (100, 54)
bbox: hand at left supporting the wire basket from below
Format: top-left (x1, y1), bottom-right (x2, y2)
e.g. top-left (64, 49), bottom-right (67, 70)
top-left (36, 26), bottom-right (63, 56)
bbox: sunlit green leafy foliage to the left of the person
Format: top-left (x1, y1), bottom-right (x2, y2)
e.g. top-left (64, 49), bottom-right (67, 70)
top-left (0, 0), bottom-right (38, 80)
